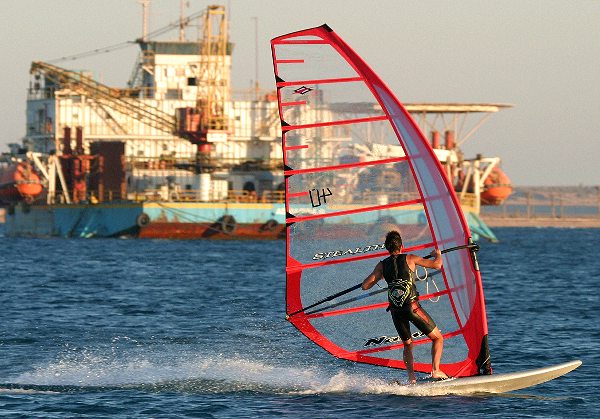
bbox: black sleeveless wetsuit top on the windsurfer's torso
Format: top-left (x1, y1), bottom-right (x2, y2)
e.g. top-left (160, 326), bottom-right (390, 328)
top-left (381, 254), bottom-right (419, 307)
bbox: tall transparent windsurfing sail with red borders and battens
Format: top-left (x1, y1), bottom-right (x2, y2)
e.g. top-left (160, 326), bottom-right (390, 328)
top-left (271, 25), bottom-right (487, 376)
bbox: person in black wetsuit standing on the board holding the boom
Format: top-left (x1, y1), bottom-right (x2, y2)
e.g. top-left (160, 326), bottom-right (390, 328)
top-left (362, 230), bottom-right (448, 383)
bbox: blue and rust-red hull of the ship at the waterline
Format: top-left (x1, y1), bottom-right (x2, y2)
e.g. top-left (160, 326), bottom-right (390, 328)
top-left (5, 202), bottom-right (496, 241)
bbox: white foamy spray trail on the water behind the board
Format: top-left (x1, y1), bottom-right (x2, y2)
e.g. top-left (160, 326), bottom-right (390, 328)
top-left (0, 355), bottom-right (436, 395)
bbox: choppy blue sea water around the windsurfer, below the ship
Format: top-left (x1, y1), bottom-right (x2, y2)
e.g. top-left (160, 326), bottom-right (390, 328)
top-left (0, 228), bottom-right (600, 418)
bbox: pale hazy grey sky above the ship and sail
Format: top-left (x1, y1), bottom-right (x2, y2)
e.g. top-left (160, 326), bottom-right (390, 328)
top-left (0, 0), bottom-right (600, 186)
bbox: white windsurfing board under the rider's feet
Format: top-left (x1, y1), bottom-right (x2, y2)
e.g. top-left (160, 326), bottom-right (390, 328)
top-left (413, 360), bottom-right (581, 396)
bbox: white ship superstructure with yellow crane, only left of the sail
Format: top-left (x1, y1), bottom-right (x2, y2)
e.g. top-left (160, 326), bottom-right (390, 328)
top-left (25, 6), bottom-right (282, 201)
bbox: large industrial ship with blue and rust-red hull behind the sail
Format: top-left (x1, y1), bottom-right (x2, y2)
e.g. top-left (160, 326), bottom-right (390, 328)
top-left (0, 2), bottom-right (511, 241)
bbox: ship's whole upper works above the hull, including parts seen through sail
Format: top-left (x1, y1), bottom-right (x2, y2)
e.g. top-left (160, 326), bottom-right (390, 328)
top-left (24, 1), bottom-right (510, 213)
